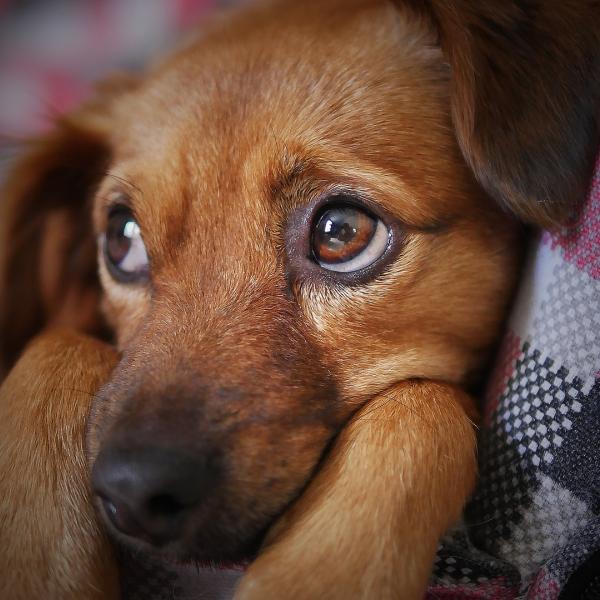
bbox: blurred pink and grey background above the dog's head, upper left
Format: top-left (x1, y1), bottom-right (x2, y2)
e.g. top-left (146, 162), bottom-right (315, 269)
top-left (0, 0), bottom-right (233, 146)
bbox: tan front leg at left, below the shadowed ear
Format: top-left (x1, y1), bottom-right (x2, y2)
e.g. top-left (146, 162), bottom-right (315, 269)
top-left (0, 332), bottom-right (117, 600)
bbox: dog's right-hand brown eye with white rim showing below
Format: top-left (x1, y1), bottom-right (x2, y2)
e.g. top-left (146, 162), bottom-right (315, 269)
top-left (312, 204), bottom-right (390, 273)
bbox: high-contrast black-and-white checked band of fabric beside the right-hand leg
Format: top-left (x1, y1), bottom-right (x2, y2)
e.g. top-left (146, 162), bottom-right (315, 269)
top-left (467, 343), bottom-right (581, 552)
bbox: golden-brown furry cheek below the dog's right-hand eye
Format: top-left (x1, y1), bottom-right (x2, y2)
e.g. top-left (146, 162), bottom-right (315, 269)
top-left (298, 208), bottom-right (522, 404)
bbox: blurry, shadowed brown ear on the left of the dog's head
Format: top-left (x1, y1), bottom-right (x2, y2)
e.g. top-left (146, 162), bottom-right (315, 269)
top-left (0, 76), bottom-right (135, 374)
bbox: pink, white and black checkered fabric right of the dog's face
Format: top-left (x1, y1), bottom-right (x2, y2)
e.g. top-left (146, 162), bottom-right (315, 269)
top-left (427, 160), bottom-right (600, 600)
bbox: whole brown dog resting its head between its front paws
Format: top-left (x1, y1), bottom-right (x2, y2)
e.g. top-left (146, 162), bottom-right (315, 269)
top-left (0, 0), bottom-right (600, 598)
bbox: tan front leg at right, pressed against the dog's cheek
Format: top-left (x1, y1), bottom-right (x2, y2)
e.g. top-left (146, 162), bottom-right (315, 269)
top-left (236, 382), bottom-right (476, 600)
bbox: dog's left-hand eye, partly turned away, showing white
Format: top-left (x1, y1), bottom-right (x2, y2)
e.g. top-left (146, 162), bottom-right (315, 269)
top-left (104, 206), bottom-right (148, 283)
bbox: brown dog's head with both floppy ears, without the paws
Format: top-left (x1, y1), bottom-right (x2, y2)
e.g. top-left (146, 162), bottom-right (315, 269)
top-left (0, 0), bottom-right (600, 559)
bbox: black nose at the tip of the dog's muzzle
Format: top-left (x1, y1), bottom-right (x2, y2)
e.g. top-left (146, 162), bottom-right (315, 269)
top-left (92, 444), bottom-right (218, 546)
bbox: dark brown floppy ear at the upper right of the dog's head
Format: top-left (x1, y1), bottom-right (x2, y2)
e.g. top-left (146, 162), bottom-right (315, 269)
top-left (408, 0), bottom-right (600, 227)
